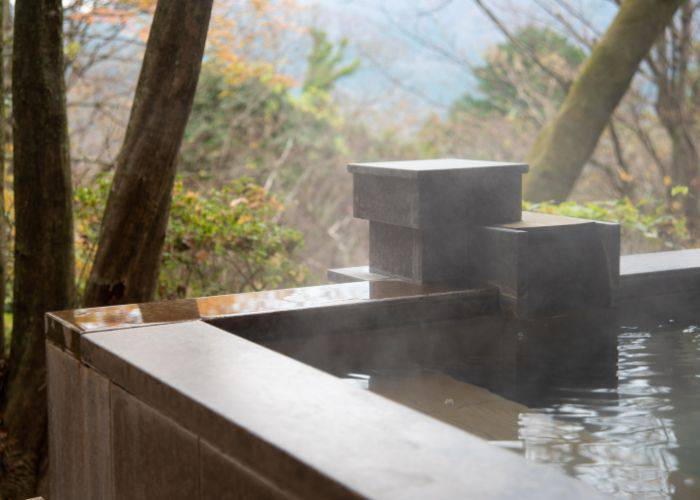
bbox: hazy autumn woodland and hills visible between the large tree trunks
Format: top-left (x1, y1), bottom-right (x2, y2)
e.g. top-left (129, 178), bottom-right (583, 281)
top-left (5, 0), bottom-right (700, 308)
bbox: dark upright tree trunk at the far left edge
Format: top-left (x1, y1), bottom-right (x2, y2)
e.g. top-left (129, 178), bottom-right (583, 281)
top-left (0, 0), bottom-right (75, 498)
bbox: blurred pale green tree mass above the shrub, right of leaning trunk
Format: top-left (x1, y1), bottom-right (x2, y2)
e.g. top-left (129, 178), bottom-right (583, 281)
top-left (181, 27), bottom-right (359, 185)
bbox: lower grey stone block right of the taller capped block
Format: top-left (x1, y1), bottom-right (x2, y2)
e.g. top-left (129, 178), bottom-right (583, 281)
top-left (468, 212), bottom-right (619, 317)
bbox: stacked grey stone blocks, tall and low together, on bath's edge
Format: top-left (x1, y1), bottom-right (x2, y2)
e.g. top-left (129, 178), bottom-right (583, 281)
top-left (348, 159), bottom-right (620, 316)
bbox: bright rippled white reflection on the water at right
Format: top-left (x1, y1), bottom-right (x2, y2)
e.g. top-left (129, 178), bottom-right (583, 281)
top-left (508, 324), bottom-right (700, 498)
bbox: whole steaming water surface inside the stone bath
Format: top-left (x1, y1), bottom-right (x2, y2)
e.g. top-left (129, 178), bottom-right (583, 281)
top-left (262, 303), bottom-right (700, 499)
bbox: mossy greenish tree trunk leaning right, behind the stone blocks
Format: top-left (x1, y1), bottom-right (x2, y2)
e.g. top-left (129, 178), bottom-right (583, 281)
top-left (525, 0), bottom-right (684, 201)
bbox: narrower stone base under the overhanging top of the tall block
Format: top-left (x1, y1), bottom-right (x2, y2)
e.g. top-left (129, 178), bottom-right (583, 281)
top-left (369, 221), bottom-right (467, 283)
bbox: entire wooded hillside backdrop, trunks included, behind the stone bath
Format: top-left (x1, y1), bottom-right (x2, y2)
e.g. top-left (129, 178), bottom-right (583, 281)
top-left (0, 0), bottom-right (700, 498)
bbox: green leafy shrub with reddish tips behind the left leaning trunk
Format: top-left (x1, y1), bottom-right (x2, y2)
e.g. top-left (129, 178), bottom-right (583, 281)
top-left (75, 176), bottom-right (305, 299)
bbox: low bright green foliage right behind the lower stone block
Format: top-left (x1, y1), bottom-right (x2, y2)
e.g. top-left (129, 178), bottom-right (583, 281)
top-left (523, 198), bottom-right (691, 251)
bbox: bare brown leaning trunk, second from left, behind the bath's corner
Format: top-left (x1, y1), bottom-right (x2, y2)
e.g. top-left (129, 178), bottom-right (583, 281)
top-left (84, 0), bottom-right (212, 306)
